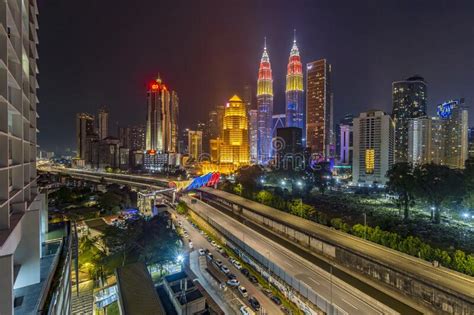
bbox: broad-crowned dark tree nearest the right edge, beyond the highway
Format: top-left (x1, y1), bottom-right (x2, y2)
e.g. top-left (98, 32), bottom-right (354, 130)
top-left (413, 163), bottom-right (464, 224)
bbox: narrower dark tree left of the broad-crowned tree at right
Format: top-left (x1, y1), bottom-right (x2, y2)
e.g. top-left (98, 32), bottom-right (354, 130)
top-left (387, 162), bottom-right (415, 221)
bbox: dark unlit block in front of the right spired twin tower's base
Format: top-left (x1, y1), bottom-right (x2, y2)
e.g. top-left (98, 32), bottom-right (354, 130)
top-left (275, 127), bottom-right (304, 170)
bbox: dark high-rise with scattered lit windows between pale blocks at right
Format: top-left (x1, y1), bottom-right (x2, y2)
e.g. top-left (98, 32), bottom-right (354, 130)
top-left (392, 76), bottom-right (427, 163)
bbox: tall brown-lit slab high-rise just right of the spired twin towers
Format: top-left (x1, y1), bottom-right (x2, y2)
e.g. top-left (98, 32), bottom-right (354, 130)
top-left (306, 59), bottom-right (334, 159)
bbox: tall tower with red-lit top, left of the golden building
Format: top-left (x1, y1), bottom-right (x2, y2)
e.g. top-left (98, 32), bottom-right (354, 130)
top-left (146, 77), bottom-right (178, 153)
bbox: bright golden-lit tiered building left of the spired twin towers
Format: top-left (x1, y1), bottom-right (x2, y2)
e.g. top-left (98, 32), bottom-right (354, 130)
top-left (220, 95), bottom-right (250, 167)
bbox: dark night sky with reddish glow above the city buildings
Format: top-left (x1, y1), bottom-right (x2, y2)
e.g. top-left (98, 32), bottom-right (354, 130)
top-left (38, 0), bottom-right (474, 151)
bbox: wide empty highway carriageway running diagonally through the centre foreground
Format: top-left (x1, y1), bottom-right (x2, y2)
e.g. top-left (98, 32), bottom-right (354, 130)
top-left (181, 196), bottom-right (381, 314)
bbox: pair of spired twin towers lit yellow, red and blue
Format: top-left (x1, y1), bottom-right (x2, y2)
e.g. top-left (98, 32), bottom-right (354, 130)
top-left (257, 33), bottom-right (304, 164)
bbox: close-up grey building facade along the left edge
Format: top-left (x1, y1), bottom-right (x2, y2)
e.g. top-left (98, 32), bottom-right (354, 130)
top-left (0, 0), bottom-right (55, 315)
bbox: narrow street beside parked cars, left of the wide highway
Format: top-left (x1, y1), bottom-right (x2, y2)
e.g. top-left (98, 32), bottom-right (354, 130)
top-left (178, 210), bottom-right (283, 315)
